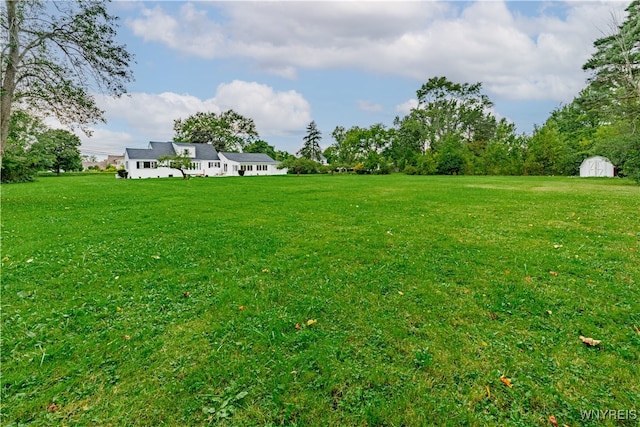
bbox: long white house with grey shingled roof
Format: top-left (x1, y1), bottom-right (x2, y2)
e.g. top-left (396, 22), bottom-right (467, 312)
top-left (124, 142), bottom-right (287, 178)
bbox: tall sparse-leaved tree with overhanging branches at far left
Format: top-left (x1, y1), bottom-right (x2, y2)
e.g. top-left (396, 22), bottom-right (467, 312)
top-left (0, 0), bottom-right (133, 171)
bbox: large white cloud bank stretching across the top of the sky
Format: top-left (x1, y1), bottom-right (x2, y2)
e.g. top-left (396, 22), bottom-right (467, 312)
top-left (127, 1), bottom-right (626, 101)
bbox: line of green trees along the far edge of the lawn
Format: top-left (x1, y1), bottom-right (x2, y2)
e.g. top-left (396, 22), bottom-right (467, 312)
top-left (0, 0), bottom-right (640, 182)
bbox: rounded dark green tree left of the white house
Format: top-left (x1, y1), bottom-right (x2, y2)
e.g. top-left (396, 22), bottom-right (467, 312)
top-left (31, 129), bottom-right (82, 175)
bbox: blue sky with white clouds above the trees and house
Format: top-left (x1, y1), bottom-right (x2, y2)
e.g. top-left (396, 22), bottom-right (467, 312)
top-left (80, 0), bottom-right (628, 158)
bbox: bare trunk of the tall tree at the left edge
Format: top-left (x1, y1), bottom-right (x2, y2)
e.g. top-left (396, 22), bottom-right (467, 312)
top-left (0, 0), bottom-right (20, 172)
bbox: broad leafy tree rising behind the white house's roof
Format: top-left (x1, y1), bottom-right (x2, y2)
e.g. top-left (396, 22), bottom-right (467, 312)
top-left (173, 110), bottom-right (258, 151)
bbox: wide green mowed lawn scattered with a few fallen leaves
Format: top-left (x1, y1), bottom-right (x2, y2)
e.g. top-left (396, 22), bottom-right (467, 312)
top-left (0, 175), bottom-right (640, 426)
